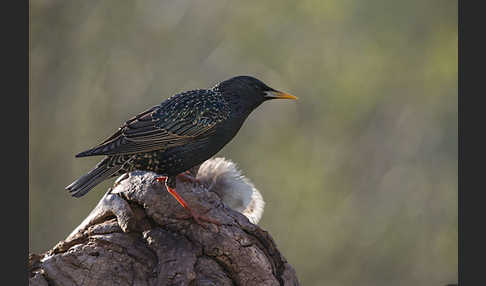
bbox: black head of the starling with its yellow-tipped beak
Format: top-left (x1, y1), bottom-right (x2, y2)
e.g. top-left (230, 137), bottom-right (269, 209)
top-left (213, 76), bottom-right (297, 112)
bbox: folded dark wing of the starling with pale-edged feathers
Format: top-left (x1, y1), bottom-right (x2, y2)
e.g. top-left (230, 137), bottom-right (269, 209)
top-left (76, 90), bottom-right (229, 157)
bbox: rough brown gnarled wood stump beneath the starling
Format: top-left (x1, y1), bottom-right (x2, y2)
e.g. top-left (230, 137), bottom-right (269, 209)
top-left (29, 163), bottom-right (299, 285)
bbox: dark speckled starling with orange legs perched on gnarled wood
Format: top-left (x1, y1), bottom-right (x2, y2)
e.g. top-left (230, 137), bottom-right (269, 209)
top-left (66, 75), bottom-right (297, 223)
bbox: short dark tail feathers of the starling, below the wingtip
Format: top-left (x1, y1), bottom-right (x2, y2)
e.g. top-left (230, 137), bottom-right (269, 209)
top-left (66, 157), bottom-right (122, 198)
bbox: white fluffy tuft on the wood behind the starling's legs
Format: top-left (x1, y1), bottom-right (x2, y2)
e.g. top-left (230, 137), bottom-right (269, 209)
top-left (197, 157), bottom-right (265, 224)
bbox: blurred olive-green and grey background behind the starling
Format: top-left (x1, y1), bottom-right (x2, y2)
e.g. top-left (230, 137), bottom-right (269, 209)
top-left (29, 0), bottom-right (458, 285)
